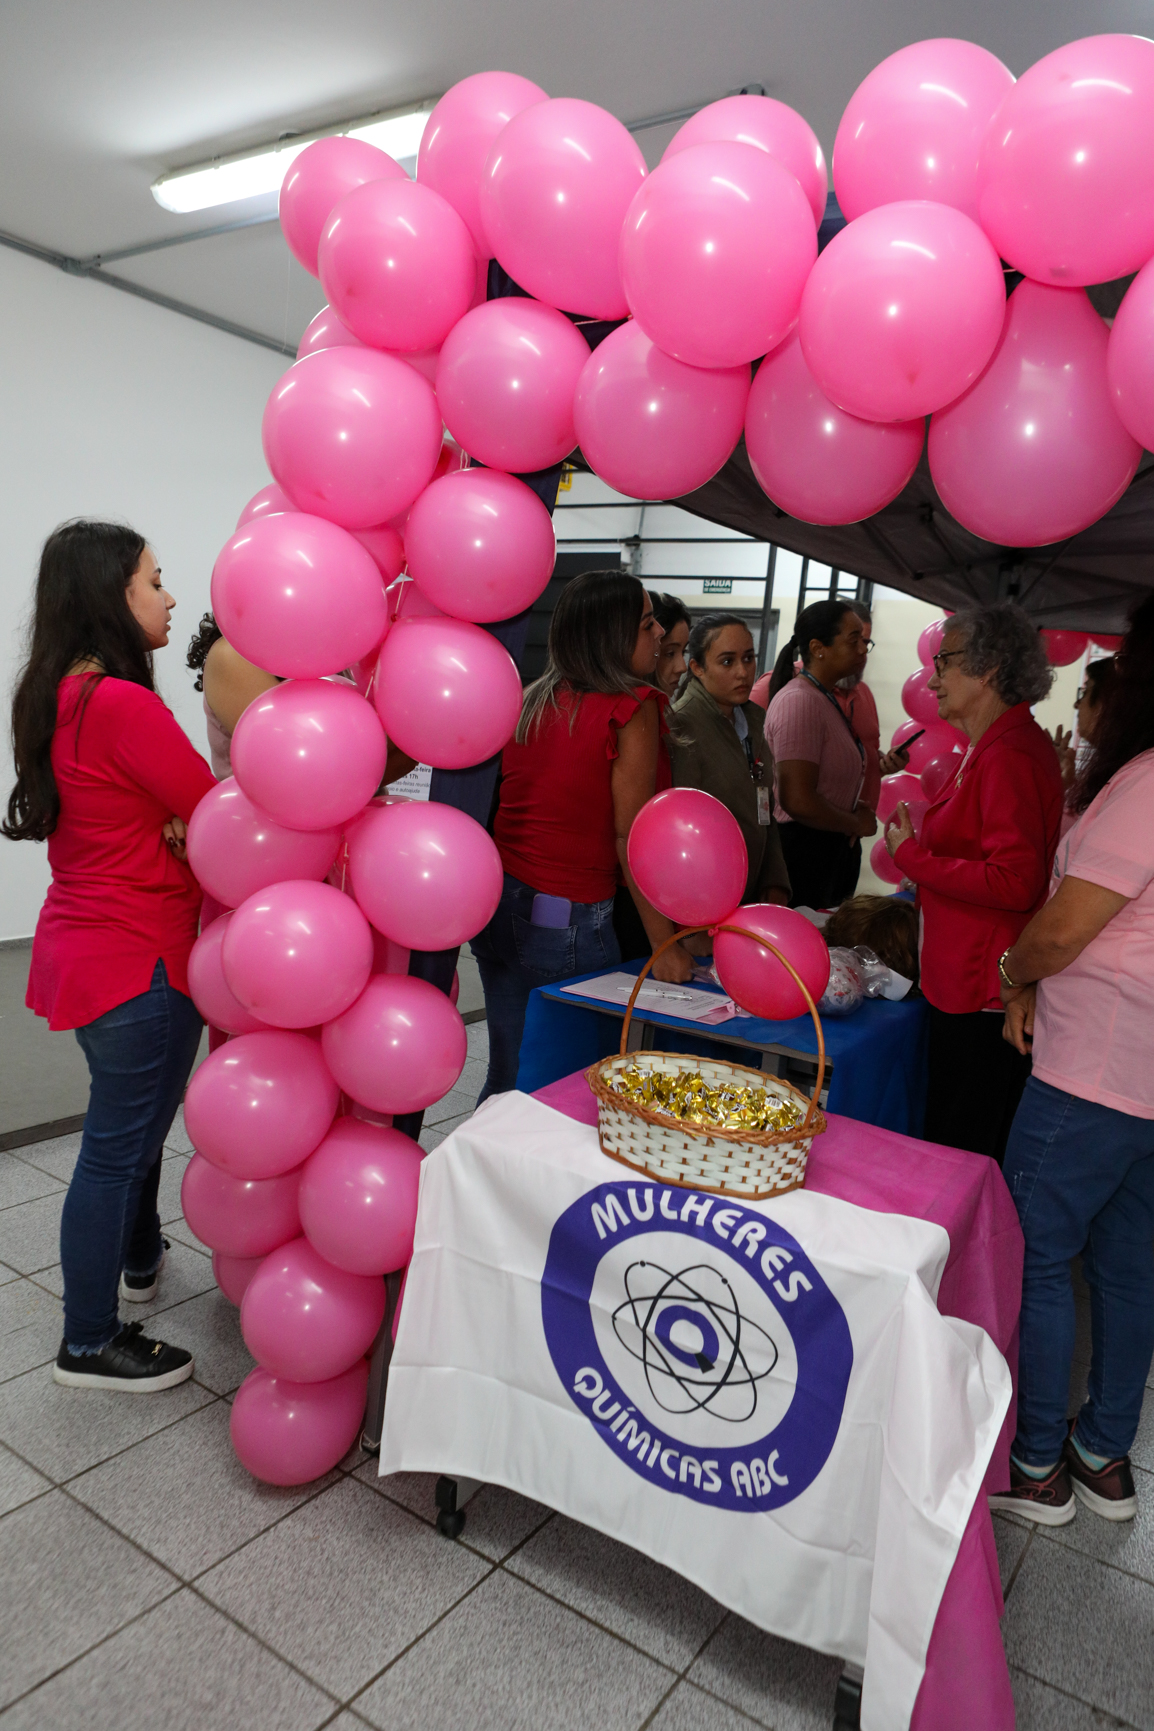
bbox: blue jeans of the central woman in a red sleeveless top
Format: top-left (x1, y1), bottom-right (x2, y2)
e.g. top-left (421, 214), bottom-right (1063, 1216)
top-left (471, 872), bottom-right (621, 1106)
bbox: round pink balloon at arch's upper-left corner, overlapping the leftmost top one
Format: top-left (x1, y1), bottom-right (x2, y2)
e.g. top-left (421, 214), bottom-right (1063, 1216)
top-left (318, 180), bottom-right (478, 353)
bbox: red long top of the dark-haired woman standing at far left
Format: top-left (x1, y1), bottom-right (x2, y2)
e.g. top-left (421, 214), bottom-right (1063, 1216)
top-left (26, 673), bottom-right (216, 1028)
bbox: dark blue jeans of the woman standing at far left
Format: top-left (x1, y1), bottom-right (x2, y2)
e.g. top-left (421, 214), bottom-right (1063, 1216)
top-left (61, 961), bottom-right (202, 1352)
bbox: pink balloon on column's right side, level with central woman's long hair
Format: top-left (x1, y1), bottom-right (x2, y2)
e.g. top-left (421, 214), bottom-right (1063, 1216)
top-left (375, 620), bottom-right (521, 769)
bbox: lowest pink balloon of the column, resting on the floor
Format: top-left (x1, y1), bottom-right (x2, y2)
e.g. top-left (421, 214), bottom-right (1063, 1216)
top-left (228, 1359), bottom-right (369, 1485)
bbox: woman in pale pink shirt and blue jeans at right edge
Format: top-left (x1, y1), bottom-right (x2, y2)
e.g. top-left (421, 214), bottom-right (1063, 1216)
top-left (974, 597), bottom-right (1154, 1527)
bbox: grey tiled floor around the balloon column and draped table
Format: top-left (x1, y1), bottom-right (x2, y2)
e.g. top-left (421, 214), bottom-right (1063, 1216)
top-left (0, 1023), bottom-right (1154, 1731)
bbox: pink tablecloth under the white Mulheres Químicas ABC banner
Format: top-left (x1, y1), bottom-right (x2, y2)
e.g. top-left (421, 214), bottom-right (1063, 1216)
top-left (535, 1071), bottom-right (1023, 1731)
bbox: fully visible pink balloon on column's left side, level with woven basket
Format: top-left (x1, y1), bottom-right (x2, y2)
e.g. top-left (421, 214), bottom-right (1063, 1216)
top-left (185, 1031), bottom-right (337, 1184)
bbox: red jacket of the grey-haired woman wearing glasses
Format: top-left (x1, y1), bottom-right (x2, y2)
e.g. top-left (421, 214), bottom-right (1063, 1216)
top-left (894, 703), bottom-right (1062, 1014)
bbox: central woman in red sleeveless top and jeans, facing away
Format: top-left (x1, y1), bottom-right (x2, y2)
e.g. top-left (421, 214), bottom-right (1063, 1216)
top-left (472, 571), bottom-right (694, 1099)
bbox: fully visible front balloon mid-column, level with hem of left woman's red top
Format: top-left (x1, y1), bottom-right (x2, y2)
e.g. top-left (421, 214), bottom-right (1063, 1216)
top-left (221, 879), bottom-right (372, 1028)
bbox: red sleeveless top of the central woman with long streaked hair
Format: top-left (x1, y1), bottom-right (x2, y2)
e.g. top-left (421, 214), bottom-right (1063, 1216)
top-left (493, 685), bottom-right (671, 902)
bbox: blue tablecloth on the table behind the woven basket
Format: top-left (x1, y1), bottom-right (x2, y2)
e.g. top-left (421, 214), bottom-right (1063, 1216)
top-left (517, 962), bottom-right (927, 1136)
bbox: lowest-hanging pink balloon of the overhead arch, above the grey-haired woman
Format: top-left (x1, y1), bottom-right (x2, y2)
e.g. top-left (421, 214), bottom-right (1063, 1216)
top-left (929, 282), bottom-right (1142, 547)
